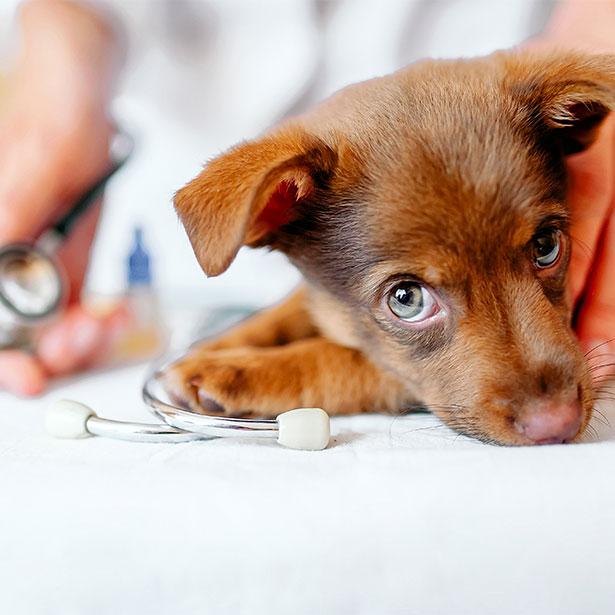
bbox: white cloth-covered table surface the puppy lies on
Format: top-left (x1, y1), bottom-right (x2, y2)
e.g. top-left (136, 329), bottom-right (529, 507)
top-left (0, 367), bottom-right (615, 615)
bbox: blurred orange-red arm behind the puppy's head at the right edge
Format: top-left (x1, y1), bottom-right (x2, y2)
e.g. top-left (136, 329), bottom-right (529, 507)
top-left (532, 0), bottom-right (615, 362)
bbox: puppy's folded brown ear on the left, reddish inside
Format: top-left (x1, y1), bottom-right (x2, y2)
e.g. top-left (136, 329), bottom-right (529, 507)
top-left (175, 128), bottom-right (337, 276)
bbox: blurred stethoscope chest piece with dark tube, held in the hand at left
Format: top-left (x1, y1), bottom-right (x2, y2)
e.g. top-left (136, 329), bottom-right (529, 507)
top-left (0, 133), bottom-right (132, 349)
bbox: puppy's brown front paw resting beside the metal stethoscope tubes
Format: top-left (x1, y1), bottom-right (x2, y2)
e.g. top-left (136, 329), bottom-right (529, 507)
top-left (161, 348), bottom-right (293, 416)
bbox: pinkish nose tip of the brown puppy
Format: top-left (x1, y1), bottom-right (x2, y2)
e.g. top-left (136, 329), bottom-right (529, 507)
top-left (515, 399), bottom-right (583, 444)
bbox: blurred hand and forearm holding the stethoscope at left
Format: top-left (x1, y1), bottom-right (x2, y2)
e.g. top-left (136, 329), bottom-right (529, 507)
top-left (0, 0), bottom-right (126, 395)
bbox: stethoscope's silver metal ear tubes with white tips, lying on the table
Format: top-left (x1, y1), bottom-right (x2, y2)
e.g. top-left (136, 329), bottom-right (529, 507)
top-left (45, 371), bottom-right (330, 450)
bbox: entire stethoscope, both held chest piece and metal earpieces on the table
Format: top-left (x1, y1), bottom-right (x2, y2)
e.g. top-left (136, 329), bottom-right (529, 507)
top-left (0, 133), bottom-right (330, 450)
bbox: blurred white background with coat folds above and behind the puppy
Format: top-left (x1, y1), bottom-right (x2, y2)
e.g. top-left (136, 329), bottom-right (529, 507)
top-left (0, 0), bottom-right (554, 305)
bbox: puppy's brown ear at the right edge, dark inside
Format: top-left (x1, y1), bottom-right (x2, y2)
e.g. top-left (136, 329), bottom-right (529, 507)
top-left (507, 52), bottom-right (615, 154)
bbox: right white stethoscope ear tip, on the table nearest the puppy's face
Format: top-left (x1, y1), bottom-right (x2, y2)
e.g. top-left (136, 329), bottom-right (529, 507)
top-left (277, 408), bottom-right (331, 451)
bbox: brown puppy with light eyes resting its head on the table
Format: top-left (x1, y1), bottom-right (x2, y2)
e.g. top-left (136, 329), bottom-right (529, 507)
top-left (166, 53), bottom-right (615, 444)
